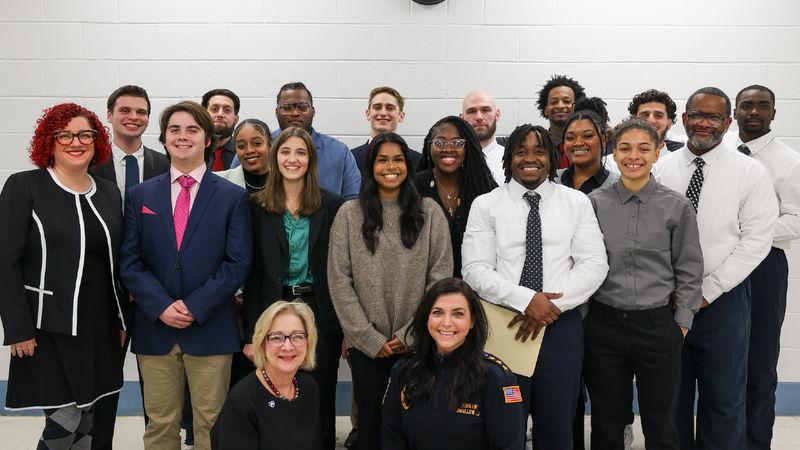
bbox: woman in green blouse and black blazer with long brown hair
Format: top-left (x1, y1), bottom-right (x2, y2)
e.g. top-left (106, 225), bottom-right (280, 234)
top-left (243, 127), bottom-right (342, 449)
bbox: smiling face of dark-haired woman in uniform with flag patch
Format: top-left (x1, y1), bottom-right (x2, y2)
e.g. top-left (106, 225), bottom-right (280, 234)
top-left (428, 292), bottom-right (473, 355)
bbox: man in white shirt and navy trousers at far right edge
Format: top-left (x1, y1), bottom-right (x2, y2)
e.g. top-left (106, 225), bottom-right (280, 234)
top-left (733, 85), bottom-right (800, 449)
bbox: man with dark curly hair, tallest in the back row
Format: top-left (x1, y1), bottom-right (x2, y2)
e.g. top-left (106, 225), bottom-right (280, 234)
top-left (536, 75), bottom-right (586, 169)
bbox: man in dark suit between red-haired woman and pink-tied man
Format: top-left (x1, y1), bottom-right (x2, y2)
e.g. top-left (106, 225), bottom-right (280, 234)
top-left (89, 85), bottom-right (169, 450)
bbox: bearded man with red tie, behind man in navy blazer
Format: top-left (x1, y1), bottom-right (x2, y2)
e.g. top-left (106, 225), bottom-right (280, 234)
top-left (200, 89), bottom-right (241, 172)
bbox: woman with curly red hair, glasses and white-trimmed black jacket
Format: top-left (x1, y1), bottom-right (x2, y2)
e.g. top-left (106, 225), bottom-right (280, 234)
top-left (0, 103), bottom-right (126, 449)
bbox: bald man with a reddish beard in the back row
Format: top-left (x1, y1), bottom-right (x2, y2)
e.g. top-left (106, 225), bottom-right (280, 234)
top-left (459, 90), bottom-right (506, 186)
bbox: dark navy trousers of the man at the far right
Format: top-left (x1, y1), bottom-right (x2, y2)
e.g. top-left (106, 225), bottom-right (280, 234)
top-left (747, 247), bottom-right (789, 450)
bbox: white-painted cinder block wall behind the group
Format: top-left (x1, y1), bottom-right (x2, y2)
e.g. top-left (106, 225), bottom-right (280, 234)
top-left (0, 0), bottom-right (800, 382)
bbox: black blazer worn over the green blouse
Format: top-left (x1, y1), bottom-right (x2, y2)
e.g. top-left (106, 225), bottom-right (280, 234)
top-left (242, 190), bottom-right (342, 343)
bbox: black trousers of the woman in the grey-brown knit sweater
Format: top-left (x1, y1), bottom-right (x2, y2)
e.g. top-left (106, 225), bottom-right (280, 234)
top-left (348, 348), bottom-right (399, 450)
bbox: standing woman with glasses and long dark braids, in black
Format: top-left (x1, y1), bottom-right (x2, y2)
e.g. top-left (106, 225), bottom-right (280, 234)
top-left (414, 116), bottom-right (497, 277)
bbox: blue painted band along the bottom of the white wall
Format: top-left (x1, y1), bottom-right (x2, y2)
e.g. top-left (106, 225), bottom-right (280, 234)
top-left (0, 380), bottom-right (800, 416)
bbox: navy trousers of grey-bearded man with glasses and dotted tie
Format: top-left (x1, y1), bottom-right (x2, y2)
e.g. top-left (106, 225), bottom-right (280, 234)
top-left (675, 279), bottom-right (750, 450)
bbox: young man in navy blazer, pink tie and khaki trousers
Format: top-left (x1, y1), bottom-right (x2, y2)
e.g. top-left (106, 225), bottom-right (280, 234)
top-left (120, 102), bottom-right (252, 450)
